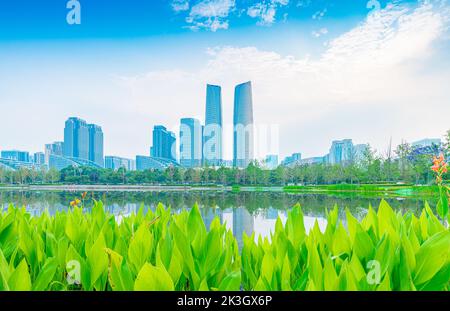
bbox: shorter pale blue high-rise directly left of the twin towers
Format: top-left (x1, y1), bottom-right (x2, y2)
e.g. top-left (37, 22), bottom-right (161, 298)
top-left (180, 118), bottom-right (203, 167)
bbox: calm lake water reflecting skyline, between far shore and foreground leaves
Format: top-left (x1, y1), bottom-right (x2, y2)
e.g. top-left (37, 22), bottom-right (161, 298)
top-left (0, 190), bottom-right (434, 246)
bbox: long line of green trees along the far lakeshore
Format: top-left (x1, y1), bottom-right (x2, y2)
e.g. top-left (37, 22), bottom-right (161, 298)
top-left (0, 131), bottom-right (450, 186)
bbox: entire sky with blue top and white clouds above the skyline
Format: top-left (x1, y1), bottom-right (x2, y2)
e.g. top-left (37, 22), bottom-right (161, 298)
top-left (0, 0), bottom-right (450, 159)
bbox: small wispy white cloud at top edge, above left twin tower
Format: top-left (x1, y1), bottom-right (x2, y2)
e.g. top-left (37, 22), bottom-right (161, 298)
top-left (186, 0), bottom-right (236, 32)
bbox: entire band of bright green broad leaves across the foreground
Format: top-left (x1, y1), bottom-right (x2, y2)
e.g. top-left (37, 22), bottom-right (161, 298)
top-left (0, 200), bottom-right (450, 291)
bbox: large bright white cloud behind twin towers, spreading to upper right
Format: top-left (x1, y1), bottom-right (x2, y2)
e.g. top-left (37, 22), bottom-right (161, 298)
top-left (121, 3), bottom-right (450, 160)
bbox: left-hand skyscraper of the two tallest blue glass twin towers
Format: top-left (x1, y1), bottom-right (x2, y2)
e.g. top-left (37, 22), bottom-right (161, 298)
top-left (203, 84), bottom-right (223, 166)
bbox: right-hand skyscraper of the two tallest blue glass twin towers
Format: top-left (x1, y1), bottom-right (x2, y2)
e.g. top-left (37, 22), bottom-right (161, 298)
top-left (233, 82), bottom-right (254, 168)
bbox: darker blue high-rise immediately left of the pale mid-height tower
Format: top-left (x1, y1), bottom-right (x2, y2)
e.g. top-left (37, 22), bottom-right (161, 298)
top-left (150, 125), bottom-right (176, 161)
